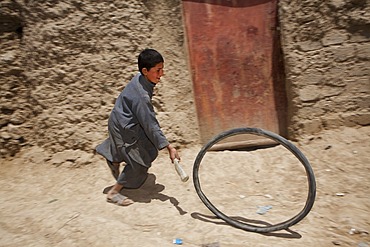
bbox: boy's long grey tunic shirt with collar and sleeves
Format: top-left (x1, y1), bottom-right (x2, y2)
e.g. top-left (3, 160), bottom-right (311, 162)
top-left (96, 73), bottom-right (169, 167)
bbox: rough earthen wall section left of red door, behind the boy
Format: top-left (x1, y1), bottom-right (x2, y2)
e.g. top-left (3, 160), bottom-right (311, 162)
top-left (0, 0), bottom-right (198, 156)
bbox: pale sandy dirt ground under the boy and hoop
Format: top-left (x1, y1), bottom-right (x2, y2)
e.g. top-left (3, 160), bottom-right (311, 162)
top-left (0, 127), bottom-right (370, 247)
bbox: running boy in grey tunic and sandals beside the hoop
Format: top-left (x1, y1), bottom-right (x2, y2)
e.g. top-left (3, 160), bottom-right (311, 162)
top-left (96, 49), bottom-right (180, 206)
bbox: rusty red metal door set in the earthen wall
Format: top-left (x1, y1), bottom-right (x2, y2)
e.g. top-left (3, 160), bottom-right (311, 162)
top-left (182, 0), bottom-right (286, 148)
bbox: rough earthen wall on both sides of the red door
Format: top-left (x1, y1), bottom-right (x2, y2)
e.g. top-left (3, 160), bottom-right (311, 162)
top-left (0, 0), bottom-right (370, 157)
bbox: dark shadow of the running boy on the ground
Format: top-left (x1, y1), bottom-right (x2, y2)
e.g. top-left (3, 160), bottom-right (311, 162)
top-left (103, 173), bottom-right (187, 215)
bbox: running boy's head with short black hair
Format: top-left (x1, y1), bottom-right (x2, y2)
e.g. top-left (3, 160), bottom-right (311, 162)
top-left (138, 49), bottom-right (164, 84)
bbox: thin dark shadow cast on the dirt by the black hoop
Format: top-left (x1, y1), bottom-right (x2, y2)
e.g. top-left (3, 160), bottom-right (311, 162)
top-left (191, 212), bottom-right (302, 239)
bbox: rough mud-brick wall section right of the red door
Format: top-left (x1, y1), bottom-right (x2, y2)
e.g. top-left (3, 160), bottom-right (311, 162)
top-left (279, 0), bottom-right (370, 138)
